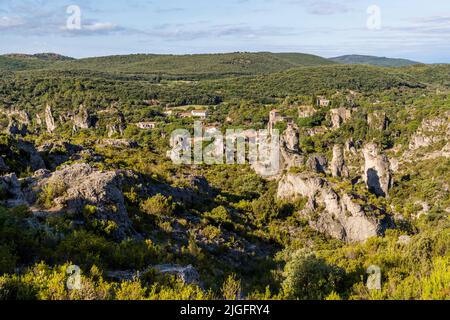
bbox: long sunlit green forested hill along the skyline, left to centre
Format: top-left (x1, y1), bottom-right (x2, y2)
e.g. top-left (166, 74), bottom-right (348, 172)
top-left (0, 52), bottom-right (335, 80)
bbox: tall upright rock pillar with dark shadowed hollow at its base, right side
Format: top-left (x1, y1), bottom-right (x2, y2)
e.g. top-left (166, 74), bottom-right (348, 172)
top-left (363, 143), bottom-right (393, 197)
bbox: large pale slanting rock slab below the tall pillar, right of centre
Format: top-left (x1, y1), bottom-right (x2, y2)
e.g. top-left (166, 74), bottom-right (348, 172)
top-left (277, 174), bottom-right (393, 242)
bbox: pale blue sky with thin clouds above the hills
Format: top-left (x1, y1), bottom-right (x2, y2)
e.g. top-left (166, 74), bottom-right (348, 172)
top-left (0, 0), bottom-right (450, 63)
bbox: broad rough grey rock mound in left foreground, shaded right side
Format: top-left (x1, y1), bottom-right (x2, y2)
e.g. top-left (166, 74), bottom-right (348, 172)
top-left (25, 163), bottom-right (134, 239)
